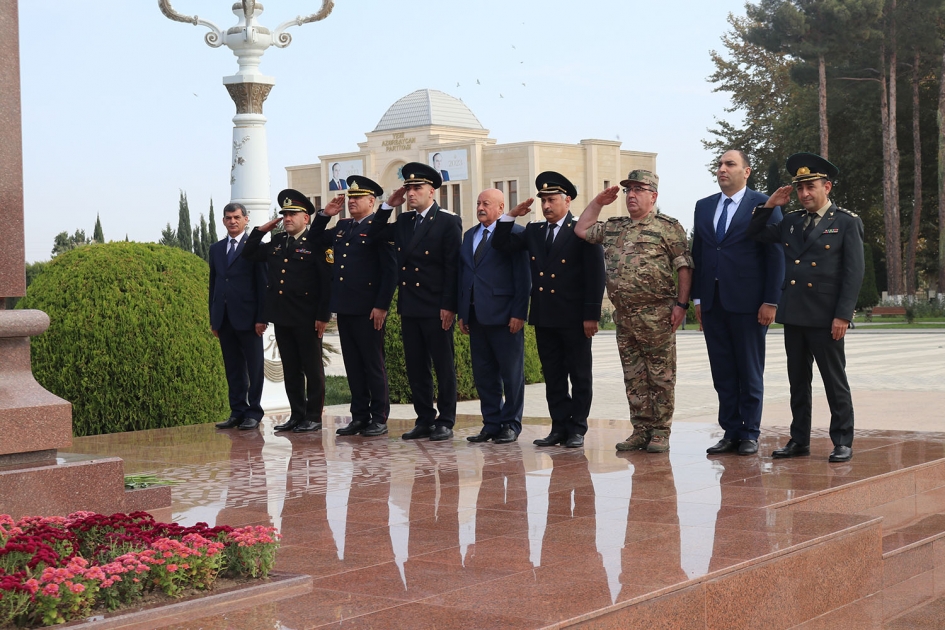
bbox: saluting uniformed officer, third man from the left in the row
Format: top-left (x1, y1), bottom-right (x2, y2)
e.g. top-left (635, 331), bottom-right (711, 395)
top-left (309, 175), bottom-right (397, 437)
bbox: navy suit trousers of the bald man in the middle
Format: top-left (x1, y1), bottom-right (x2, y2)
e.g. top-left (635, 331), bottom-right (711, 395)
top-left (469, 306), bottom-right (525, 435)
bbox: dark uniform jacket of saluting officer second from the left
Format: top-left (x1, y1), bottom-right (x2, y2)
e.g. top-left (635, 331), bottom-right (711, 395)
top-left (243, 228), bottom-right (331, 326)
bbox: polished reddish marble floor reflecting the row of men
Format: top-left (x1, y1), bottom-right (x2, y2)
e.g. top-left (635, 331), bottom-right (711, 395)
top-left (66, 416), bottom-right (945, 628)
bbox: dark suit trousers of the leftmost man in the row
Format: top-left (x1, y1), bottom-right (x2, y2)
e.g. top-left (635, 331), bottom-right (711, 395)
top-left (217, 313), bottom-right (266, 420)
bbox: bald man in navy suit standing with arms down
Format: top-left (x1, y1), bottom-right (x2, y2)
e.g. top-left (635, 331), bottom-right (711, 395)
top-left (458, 188), bottom-right (531, 444)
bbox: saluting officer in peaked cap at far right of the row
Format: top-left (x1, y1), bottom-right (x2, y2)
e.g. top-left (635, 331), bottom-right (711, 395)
top-left (748, 153), bottom-right (864, 462)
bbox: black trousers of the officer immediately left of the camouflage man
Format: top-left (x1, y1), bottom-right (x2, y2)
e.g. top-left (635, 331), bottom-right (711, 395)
top-left (535, 324), bottom-right (594, 435)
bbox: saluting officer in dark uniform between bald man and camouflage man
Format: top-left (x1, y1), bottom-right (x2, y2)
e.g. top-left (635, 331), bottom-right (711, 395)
top-left (492, 171), bottom-right (604, 448)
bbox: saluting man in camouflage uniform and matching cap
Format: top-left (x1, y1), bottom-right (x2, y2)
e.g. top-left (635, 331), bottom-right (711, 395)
top-left (574, 169), bottom-right (693, 453)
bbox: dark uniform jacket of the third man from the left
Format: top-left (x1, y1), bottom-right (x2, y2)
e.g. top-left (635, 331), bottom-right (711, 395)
top-left (309, 214), bottom-right (397, 315)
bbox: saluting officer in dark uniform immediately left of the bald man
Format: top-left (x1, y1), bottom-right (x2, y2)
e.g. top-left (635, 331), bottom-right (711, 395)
top-left (367, 162), bottom-right (463, 441)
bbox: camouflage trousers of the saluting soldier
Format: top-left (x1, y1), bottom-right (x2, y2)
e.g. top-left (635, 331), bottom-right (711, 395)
top-left (614, 302), bottom-right (676, 437)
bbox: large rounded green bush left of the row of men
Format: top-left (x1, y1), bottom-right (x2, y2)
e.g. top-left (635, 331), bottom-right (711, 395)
top-left (17, 242), bottom-right (229, 435)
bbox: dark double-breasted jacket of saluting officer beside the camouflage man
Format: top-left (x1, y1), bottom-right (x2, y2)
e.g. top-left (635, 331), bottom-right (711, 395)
top-left (492, 212), bottom-right (604, 328)
